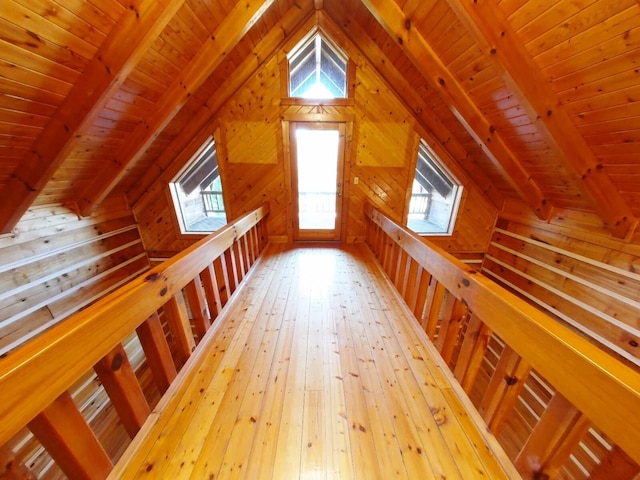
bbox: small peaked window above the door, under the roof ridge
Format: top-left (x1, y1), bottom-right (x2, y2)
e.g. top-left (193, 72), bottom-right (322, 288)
top-left (289, 33), bottom-right (347, 99)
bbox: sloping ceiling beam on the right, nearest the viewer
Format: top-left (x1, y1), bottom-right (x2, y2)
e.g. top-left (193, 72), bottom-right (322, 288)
top-left (447, 0), bottom-right (638, 238)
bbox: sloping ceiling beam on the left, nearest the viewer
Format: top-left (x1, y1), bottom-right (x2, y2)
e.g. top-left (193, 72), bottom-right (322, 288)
top-left (0, 0), bottom-right (184, 233)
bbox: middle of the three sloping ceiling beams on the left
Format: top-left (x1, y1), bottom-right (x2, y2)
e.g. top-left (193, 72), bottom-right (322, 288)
top-left (79, 0), bottom-right (274, 215)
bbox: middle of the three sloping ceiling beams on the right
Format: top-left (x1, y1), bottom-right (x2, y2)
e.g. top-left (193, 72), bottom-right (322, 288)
top-left (363, 0), bottom-right (551, 220)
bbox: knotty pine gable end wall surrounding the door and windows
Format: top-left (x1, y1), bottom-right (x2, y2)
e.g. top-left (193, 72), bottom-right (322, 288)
top-left (134, 28), bottom-right (496, 257)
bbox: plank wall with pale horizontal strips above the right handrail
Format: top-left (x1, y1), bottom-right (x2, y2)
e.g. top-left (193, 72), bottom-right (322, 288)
top-left (482, 202), bottom-right (640, 368)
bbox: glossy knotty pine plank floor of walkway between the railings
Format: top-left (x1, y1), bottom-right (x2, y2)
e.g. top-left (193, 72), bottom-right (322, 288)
top-left (112, 245), bottom-right (519, 480)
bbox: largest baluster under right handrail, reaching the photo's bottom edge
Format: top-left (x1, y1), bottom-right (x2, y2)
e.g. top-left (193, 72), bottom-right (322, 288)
top-left (514, 392), bottom-right (592, 478)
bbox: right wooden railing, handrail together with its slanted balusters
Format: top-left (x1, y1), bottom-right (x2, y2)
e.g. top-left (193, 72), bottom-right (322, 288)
top-left (365, 205), bottom-right (640, 478)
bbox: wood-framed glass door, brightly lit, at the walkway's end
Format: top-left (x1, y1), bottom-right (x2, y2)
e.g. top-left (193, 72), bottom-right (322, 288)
top-left (290, 122), bottom-right (345, 241)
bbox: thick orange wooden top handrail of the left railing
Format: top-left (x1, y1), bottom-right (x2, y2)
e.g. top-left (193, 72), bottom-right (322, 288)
top-left (0, 204), bottom-right (269, 445)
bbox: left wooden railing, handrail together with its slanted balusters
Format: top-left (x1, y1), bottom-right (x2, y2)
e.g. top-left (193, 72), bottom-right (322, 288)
top-left (0, 205), bottom-right (269, 478)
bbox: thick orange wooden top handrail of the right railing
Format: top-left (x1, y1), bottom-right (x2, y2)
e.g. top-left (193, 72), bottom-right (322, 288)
top-left (365, 205), bottom-right (640, 462)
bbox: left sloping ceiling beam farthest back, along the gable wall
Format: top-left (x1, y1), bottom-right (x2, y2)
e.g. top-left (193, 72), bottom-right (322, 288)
top-left (127, 1), bottom-right (315, 210)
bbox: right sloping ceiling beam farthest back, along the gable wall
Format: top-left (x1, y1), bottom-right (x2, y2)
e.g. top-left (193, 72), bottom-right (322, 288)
top-left (319, 10), bottom-right (504, 210)
